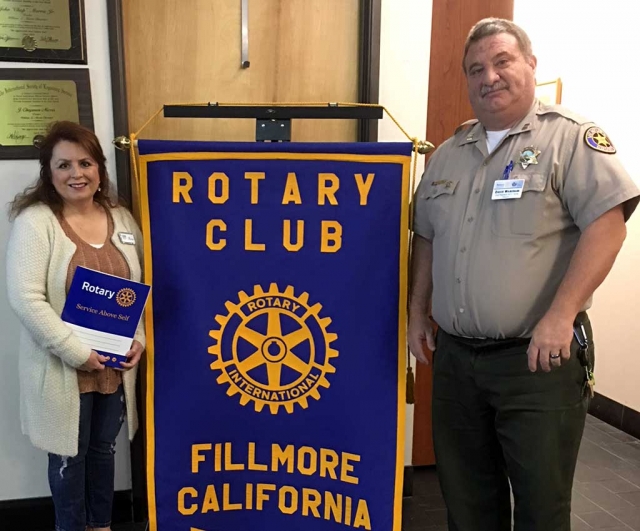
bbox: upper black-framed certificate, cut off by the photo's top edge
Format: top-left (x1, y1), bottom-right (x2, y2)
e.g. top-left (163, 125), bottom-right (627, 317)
top-left (0, 0), bottom-right (87, 64)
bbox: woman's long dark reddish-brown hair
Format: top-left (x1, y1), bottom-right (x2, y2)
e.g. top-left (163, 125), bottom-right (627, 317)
top-left (9, 121), bottom-right (117, 219)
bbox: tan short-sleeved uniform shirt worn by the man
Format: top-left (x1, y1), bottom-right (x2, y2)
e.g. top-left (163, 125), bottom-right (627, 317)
top-left (413, 101), bottom-right (640, 339)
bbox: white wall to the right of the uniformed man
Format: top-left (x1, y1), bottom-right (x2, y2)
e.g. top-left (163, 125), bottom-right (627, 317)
top-left (514, 0), bottom-right (640, 411)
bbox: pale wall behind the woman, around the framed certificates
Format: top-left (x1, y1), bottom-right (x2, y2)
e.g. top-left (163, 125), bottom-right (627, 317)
top-left (0, 4), bottom-right (131, 500)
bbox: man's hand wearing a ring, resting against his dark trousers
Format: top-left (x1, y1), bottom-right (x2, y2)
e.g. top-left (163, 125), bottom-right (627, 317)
top-left (527, 312), bottom-right (575, 372)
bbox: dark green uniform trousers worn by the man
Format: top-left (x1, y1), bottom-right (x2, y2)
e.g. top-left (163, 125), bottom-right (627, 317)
top-left (433, 314), bottom-right (593, 531)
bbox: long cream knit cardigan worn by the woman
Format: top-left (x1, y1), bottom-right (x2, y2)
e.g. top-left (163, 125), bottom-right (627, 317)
top-left (7, 204), bottom-right (145, 456)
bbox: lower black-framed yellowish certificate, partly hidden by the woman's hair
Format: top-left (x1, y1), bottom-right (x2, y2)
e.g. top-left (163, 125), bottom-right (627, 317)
top-left (0, 68), bottom-right (93, 159)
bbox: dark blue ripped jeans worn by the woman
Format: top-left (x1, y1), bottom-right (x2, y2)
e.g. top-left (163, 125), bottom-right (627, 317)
top-left (49, 385), bottom-right (125, 531)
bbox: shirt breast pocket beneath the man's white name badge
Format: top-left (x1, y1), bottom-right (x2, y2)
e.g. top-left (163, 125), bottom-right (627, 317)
top-left (491, 173), bottom-right (547, 238)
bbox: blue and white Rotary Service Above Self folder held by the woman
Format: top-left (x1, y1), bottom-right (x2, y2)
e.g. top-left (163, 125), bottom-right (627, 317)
top-left (61, 267), bottom-right (151, 368)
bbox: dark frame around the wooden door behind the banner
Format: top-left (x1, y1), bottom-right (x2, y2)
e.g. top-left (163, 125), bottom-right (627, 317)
top-left (105, 0), bottom-right (382, 522)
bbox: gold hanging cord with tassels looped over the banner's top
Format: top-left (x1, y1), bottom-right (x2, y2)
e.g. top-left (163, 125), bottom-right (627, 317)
top-left (113, 102), bottom-right (435, 404)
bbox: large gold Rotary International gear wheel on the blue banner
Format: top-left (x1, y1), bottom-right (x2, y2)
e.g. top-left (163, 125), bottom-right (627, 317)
top-left (209, 283), bottom-right (338, 415)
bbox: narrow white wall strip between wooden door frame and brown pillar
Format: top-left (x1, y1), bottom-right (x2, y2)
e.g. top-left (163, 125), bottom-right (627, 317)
top-left (378, 0), bottom-right (432, 465)
